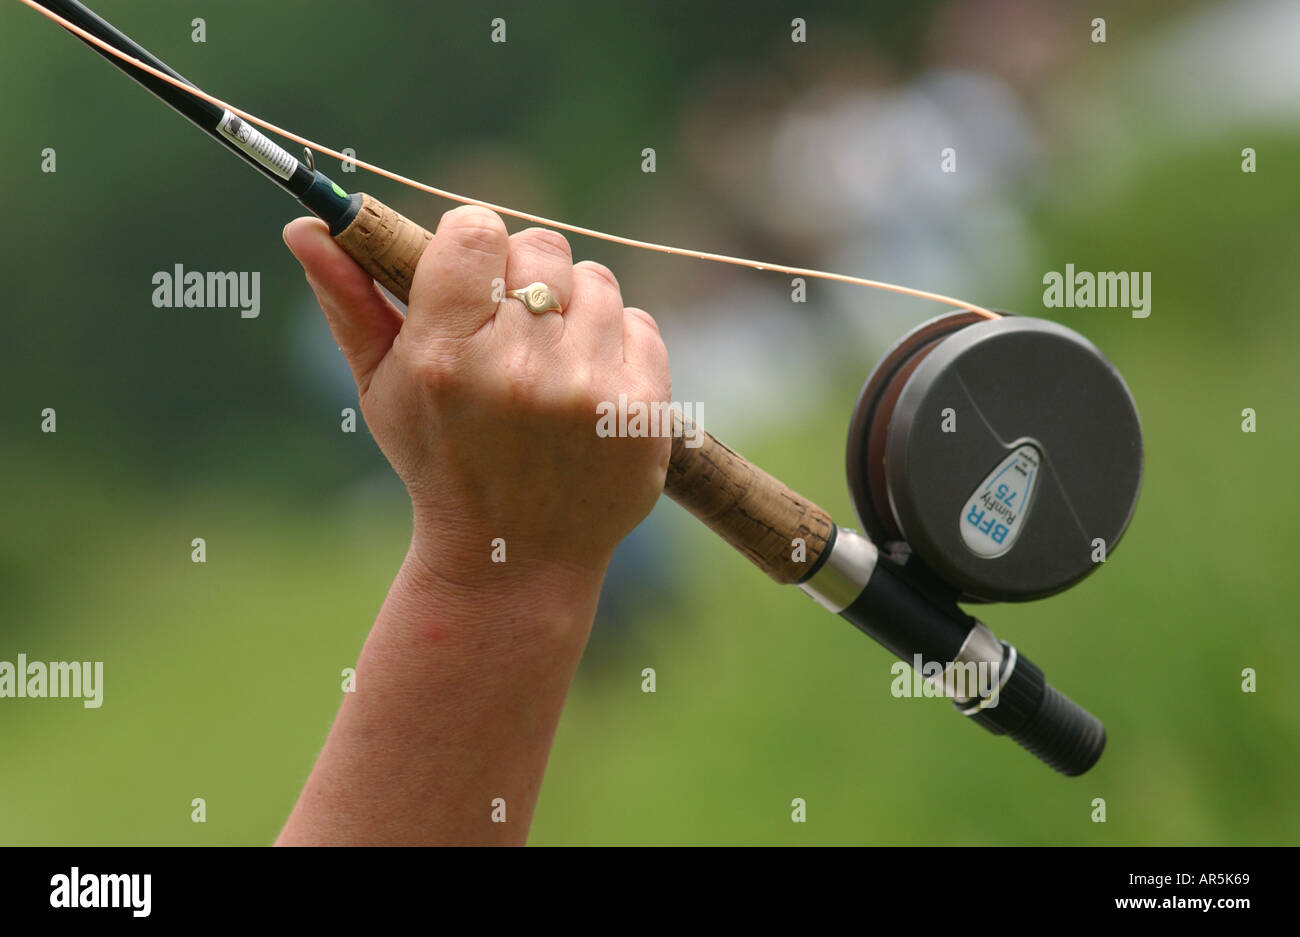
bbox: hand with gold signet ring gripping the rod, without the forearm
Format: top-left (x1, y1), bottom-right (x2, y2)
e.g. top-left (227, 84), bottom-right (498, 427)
top-left (285, 207), bottom-right (670, 600)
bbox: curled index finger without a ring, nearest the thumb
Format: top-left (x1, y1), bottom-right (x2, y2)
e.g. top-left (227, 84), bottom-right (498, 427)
top-left (407, 205), bottom-right (510, 339)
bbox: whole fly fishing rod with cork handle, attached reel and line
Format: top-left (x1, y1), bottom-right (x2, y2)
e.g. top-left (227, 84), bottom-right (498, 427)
top-left (22, 0), bottom-right (1141, 776)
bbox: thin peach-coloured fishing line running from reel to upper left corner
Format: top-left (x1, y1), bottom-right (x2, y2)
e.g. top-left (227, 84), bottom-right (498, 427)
top-left (18, 0), bottom-right (1000, 318)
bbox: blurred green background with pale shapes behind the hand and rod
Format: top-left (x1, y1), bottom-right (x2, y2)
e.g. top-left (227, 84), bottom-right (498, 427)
top-left (0, 0), bottom-right (1300, 843)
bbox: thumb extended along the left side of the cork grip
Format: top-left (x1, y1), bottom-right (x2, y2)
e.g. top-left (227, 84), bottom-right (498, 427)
top-left (285, 218), bottom-right (403, 394)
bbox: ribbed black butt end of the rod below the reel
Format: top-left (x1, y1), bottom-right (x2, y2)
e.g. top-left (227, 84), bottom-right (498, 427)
top-left (957, 645), bottom-right (1106, 777)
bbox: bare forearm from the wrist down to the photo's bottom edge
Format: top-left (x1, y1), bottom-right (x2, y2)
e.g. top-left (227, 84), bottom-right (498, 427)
top-left (278, 551), bottom-right (599, 845)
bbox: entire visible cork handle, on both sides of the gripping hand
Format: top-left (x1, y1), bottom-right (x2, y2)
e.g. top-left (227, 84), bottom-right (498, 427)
top-left (334, 195), bottom-right (835, 584)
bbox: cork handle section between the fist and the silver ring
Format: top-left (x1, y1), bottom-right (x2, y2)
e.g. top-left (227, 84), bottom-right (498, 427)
top-left (663, 408), bottom-right (835, 584)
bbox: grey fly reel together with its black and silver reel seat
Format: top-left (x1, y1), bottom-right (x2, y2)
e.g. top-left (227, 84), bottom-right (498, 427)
top-left (780, 312), bottom-right (1141, 776)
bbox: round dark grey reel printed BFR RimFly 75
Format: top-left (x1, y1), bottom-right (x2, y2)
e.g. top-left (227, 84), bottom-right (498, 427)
top-left (848, 312), bottom-right (1143, 602)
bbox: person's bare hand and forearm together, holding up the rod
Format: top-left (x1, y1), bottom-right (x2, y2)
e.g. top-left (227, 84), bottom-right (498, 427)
top-left (278, 207), bottom-right (671, 845)
